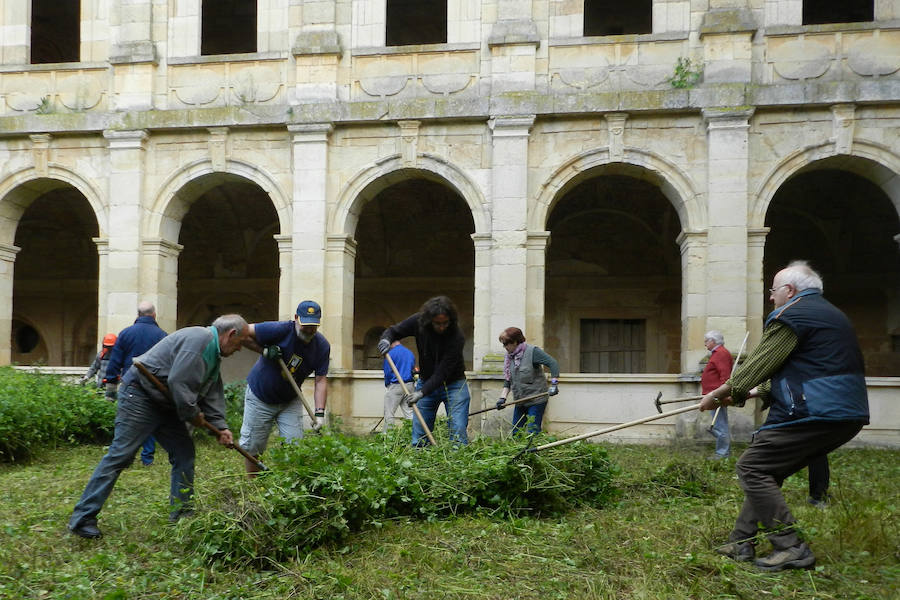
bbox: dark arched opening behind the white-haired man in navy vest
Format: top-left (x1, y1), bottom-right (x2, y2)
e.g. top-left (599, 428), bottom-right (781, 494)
top-left (763, 166), bottom-right (900, 376)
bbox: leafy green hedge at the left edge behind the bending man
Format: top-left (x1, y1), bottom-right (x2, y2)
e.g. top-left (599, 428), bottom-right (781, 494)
top-left (0, 367), bottom-right (116, 462)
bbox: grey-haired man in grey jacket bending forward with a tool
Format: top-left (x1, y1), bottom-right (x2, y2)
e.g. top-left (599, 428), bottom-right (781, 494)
top-left (69, 315), bottom-right (249, 538)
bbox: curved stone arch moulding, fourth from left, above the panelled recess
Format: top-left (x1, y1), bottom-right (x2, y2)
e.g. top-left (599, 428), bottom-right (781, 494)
top-left (528, 148), bottom-right (707, 231)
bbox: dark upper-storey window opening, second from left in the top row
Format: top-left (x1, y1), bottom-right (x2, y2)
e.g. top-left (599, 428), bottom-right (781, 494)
top-left (200, 0), bottom-right (257, 56)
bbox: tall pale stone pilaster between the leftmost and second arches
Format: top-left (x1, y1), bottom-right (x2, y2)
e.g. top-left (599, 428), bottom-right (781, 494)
top-left (105, 130), bottom-right (148, 331)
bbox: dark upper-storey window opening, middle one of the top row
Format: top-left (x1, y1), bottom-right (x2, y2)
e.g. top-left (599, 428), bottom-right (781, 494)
top-left (384, 0), bottom-right (447, 46)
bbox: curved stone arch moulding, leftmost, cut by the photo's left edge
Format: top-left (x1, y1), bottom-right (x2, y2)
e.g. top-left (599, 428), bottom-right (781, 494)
top-left (0, 163), bottom-right (108, 245)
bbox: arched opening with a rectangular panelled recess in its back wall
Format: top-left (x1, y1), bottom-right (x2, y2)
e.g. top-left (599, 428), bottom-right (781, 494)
top-left (544, 167), bottom-right (682, 373)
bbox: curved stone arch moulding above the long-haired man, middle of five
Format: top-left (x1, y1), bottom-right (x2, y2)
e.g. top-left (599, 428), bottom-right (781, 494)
top-left (328, 154), bottom-right (491, 235)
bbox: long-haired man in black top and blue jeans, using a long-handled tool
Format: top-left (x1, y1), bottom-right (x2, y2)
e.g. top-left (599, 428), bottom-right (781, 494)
top-left (378, 296), bottom-right (470, 446)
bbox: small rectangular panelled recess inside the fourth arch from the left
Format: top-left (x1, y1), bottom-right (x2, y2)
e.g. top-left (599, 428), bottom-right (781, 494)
top-left (581, 319), bottom-right (647, 373)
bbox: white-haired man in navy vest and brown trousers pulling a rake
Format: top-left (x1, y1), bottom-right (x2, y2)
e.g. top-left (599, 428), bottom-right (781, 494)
top-left (700, 261), bottom-right (869, 571)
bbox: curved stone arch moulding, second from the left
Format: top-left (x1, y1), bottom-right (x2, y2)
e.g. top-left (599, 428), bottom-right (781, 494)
top-left (143, 159), bottom-right (292, 241)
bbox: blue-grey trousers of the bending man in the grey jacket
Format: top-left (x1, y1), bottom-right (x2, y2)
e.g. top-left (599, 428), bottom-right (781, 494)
top-left (69, 384), bottom-right (194, 528)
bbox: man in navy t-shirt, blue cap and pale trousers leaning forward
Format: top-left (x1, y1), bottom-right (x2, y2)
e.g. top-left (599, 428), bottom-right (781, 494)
top-left (240, 300), bottom-right (331, 477)
